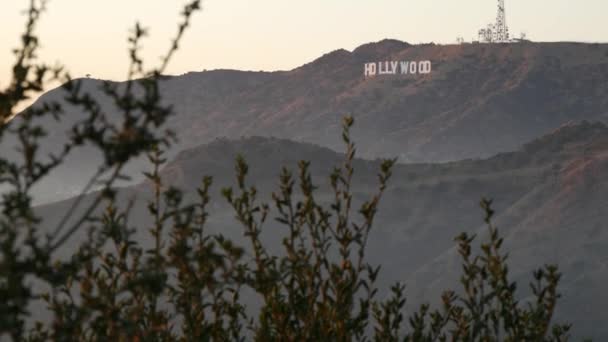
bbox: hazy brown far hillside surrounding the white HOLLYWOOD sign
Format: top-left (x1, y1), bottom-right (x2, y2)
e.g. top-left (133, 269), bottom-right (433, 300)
top-left (0, 40), bottom-right (608, 202)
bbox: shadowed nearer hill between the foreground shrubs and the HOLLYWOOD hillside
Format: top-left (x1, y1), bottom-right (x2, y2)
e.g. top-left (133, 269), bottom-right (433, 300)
top-left (37, 122), bottom-right (608, 340)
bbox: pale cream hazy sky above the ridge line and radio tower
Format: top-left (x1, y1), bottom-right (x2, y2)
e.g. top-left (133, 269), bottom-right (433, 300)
top-left (0, 0), bottom-right (608, 87)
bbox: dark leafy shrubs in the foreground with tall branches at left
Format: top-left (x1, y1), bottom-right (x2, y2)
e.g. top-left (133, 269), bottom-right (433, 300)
top-left (0, 1), bottom-right (569, 341)
